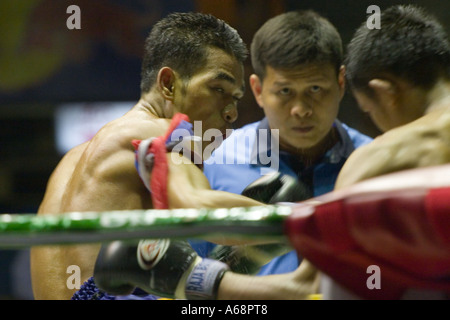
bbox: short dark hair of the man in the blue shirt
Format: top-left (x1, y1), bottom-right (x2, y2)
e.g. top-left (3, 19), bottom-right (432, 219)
top-left (250, 10), bottom-right (343, 80)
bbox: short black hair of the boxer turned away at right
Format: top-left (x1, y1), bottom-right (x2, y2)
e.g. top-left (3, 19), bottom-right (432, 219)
top-left (345, 5), bottom-right (450, 95)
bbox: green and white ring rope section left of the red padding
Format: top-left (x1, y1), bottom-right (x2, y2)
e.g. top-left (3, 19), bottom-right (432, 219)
top-left (0, 205), bottom-right (292, 249)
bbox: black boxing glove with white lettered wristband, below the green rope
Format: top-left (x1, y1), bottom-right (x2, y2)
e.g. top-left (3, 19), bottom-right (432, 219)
top-left (94, 239), bottom-right (229, 300)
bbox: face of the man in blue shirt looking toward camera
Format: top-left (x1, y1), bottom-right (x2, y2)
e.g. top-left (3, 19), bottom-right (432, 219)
top-left (250, 64), bottom-right (344, 152)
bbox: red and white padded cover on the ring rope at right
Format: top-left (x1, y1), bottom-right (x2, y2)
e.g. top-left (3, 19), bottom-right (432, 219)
top-left (285, 165), bottom-right (450, 299)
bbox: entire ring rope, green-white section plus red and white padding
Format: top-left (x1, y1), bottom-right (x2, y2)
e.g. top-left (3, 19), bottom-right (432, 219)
top-left (4, 165), bottom-right (450, 299)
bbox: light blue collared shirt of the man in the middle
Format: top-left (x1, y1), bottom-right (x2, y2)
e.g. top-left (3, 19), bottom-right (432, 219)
top-left (191, 118), bottom-right (372, 275)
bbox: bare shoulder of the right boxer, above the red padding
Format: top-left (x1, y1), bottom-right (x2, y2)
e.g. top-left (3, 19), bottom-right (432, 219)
top-left (336, 114), bottom-right (450, 188)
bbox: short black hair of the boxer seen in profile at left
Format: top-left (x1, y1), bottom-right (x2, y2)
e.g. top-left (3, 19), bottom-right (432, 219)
top-left (141, 12), bottom-right (248, 92)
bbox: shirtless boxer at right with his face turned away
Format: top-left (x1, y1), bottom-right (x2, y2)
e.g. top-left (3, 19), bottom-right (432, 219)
top-left (219, 6), bottom-right (450, 299)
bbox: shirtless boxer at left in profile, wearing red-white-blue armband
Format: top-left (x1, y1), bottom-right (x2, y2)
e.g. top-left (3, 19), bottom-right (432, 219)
top-left (31, 13), bottom-right (260, 299)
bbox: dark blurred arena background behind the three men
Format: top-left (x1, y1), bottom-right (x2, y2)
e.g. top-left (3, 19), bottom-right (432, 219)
top-left (0, 0), bottom-right (450, 299)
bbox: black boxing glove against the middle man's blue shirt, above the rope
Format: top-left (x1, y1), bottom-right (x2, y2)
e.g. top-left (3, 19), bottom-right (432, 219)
top-left (242, 172), bottom-right (313, 204)
